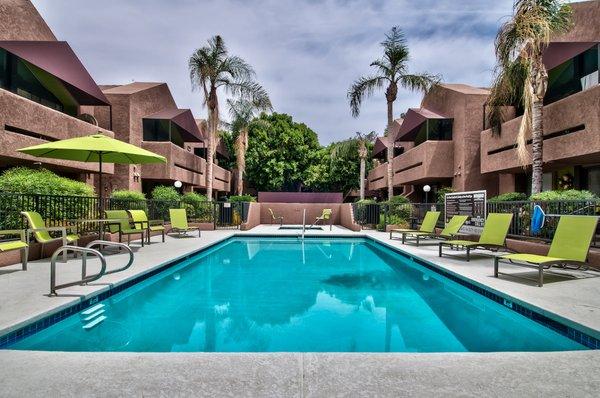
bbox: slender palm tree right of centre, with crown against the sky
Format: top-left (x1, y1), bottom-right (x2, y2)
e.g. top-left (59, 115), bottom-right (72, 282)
top-left (347, 26), bottom-right (440, 198)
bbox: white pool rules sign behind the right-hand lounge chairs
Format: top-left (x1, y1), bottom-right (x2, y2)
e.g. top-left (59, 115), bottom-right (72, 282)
top-left (444, 191), bottom-right (487, 234)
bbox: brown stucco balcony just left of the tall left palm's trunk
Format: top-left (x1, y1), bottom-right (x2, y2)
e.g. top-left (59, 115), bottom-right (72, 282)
top-left (141, 141), bottom-right (206, 188)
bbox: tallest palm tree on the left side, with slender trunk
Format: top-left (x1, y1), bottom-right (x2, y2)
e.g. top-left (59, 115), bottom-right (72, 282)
top-left (188, 35), bottom-right (266, 198)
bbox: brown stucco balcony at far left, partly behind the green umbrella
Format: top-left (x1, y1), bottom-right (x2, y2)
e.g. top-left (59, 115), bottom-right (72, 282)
top-left (0, 89), bottom-right (114, 174)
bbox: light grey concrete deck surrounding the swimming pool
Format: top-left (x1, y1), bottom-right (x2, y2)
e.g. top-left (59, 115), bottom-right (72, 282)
top-left (0, 225), bottom-right (600, 396)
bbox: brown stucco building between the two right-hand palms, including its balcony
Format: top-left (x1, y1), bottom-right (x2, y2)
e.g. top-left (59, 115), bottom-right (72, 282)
top-left (367, 84), bottom-right (497, 200)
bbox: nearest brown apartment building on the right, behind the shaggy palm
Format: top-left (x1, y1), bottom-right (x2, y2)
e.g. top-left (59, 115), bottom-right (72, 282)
top-left (481, 1), bottom-right (600, 194)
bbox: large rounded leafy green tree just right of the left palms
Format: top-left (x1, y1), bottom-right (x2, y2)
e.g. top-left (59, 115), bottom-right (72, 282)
top-left (246, 113), bottom-right (320, 191)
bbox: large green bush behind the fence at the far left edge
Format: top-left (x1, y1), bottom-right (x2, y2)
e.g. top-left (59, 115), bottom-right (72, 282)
top-left (0, 167), bottom-right (97, 229)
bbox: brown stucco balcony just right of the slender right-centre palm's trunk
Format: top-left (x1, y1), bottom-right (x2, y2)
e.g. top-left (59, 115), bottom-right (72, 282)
top-left (394, 141), bottom-right (454, 186)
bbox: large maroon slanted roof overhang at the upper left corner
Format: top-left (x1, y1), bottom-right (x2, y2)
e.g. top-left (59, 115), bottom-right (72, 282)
top-left (0, 41), bottom-right (110, 106)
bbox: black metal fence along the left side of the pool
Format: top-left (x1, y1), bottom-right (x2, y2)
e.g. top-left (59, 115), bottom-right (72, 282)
top-left (0, 192), bottom-right (249, 230)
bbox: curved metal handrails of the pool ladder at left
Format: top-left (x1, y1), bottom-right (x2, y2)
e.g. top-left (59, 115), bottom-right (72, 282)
top-left (50, 240), bottom-right (134, 296)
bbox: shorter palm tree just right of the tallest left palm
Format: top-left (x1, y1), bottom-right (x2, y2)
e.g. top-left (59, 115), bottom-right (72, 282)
top-left (227, 97), bottom-right (273, 195)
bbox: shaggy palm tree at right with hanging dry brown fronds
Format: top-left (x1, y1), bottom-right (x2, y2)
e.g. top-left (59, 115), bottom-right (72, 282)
top-left (488, 0), bottom-right (572, 194)
